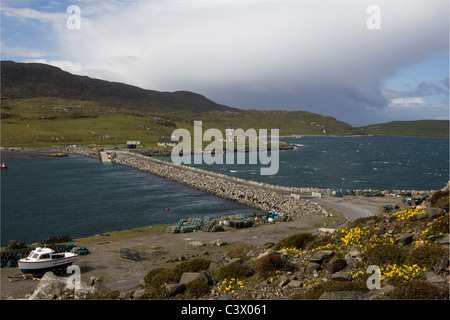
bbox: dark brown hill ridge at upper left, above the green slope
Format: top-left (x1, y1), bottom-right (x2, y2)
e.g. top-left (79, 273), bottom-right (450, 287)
top-left (1, 61), bottom-right (239, 112)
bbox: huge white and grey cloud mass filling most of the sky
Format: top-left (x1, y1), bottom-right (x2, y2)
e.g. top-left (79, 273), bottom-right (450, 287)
top-left (1, 0), bottom-right (448, 125)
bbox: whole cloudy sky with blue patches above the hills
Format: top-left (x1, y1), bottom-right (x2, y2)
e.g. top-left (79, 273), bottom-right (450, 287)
top-left (1, 0), bottom-right (449, 126)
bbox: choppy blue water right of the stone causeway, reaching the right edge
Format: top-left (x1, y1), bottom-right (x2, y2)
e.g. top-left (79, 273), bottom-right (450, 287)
top-left (180, 137), bottom-right (449, 190)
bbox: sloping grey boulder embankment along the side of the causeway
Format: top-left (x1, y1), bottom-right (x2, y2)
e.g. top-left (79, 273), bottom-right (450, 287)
top-left (112, 152), bottom-right (326, 217)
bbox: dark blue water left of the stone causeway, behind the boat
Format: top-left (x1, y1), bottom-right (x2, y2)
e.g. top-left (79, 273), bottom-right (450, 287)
top-left (1, 153), bottom-right (255, 246)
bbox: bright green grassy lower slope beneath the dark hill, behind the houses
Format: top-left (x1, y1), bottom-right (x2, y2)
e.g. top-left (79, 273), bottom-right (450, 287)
top-left (1, 98), bottom-right (357, 147)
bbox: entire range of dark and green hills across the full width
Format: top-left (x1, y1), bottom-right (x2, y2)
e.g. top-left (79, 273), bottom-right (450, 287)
top-left (1, 61), bottom-right (449, 147)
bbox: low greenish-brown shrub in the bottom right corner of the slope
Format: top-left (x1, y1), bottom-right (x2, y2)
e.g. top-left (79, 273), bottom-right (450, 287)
top-left (386, 280), bottom-right (449, 300)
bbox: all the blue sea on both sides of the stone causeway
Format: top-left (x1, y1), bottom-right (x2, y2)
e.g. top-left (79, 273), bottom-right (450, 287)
top-left (1, 137), bottom-right (449, 246)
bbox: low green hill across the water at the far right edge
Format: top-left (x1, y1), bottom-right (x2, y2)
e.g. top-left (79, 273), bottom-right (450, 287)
top-left (358, 120), bottom-right (450, 138)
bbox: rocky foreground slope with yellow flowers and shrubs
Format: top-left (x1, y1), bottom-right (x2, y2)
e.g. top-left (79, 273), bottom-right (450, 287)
top-left (25, 198), bottom-right (450, 300)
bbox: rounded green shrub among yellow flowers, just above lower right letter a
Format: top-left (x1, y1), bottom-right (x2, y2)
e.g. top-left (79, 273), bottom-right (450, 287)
top-left (363, 244), bottom-right (407, 267)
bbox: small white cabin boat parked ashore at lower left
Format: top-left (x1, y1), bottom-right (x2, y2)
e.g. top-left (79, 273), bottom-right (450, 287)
top-left (18, 247), bottom-right (78, 273)
